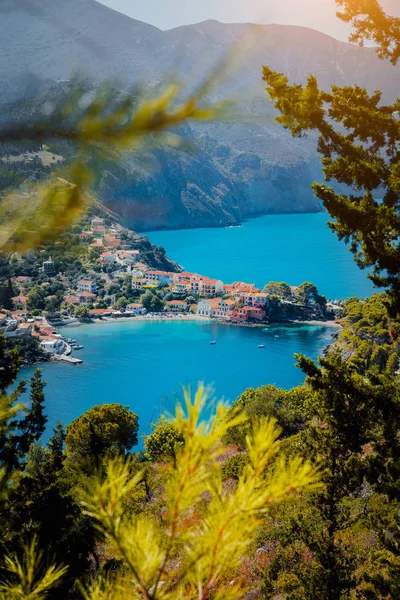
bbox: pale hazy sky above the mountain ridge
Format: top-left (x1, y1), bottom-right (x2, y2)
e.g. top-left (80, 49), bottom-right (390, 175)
top-left (100, 0), bottom-right (352, 39)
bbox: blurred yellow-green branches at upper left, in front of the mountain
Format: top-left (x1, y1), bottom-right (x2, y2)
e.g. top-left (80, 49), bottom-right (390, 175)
top-left (0, 82), bottom-right (225, 251)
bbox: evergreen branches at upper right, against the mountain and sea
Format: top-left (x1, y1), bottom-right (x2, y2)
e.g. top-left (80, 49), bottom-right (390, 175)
top-left (263, 0), bottom-right (400, 312)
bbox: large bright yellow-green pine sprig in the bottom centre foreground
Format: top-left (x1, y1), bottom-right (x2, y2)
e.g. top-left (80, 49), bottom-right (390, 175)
top-left (81, 388), bottom-right (318, 600)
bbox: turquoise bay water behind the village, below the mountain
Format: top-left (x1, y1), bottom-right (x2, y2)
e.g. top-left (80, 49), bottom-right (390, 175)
top-left (146, 213), bottom-right (373, 298)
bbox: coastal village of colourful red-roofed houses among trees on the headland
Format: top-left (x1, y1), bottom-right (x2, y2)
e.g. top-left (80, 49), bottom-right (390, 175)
top-left (0, 216), bottom-right (340, 364)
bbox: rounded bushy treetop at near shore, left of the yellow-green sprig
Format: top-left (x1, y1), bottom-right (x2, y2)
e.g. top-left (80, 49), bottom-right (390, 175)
top-left (65, 404), bottom-right (139, 460)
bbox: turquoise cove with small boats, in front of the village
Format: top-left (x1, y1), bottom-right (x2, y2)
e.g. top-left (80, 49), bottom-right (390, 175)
top-left (19, 321), bottom-right (333, 439)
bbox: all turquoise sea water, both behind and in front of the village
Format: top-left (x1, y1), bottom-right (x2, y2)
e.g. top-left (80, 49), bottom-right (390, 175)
top-left (16, 213), bottom-right (372, 440)
